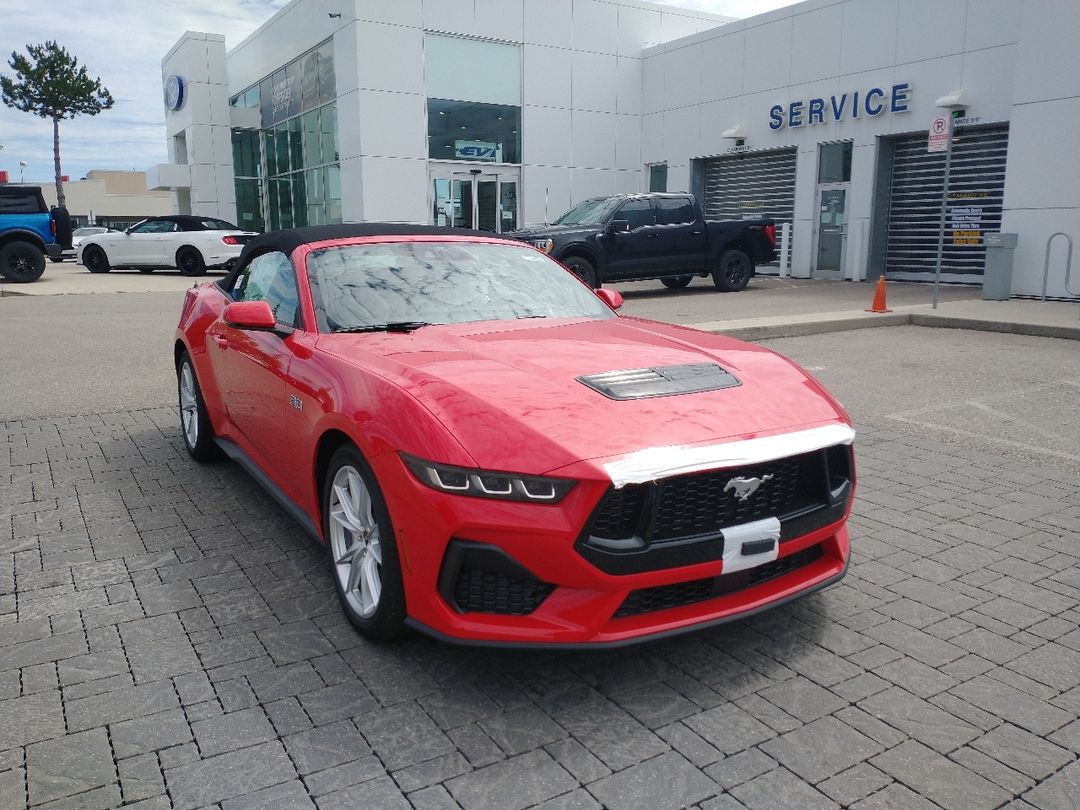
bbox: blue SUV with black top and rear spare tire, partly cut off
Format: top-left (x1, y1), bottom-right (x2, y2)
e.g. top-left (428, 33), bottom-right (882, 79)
top-left (0, 185), bottom-right (71, 283)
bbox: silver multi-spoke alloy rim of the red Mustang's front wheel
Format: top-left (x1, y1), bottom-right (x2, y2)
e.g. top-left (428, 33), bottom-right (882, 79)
top-left (328, 464), bottom-right (382, 619)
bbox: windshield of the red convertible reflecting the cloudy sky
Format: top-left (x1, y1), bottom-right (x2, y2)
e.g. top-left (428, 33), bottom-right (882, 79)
top-left (307, 242), bottom-right (615, 332)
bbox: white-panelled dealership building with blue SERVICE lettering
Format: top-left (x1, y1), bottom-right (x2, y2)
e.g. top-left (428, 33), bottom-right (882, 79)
top-left (147, 0), bottom-right (1080, 297)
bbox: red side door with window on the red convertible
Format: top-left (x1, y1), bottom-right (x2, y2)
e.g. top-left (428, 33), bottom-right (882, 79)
top-left (207, 251), bottom-right (301, 479)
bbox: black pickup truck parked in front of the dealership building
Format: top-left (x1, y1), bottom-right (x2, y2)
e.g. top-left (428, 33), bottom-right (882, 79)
top-left (507, 193), bottom-right (777, 292)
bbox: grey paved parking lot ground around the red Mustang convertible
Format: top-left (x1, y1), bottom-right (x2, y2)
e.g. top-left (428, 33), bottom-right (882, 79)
top-left (0, 279), bottom-right (1080, 810)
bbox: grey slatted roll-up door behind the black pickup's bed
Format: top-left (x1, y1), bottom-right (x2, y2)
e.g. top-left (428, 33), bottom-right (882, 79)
top-left (703, 148), bottom-right (796, 270)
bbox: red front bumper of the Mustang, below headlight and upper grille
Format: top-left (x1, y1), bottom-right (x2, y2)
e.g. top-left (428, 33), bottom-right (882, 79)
top-left (373, 454), bottom-right (852, 647)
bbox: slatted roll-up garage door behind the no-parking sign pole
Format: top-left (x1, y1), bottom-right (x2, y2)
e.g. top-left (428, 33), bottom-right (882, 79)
top-left (885, 124), bottom-right (1009, 282)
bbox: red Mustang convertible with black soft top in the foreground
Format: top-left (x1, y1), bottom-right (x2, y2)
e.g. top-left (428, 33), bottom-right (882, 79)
top-left (175, 225), bottom-right (854, 646)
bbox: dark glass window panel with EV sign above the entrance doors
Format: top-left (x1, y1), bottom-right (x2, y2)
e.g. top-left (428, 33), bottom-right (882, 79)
top-left (428, 98), bottom-right (522, 163)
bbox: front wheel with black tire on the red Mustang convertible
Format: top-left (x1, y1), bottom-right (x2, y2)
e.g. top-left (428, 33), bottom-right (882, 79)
top-left (323, 445), bottom-right (406, 642)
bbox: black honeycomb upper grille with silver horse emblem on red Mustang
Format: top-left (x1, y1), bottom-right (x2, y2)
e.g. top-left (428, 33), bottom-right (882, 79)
top-left (589, 451), bottom-right (827, 543)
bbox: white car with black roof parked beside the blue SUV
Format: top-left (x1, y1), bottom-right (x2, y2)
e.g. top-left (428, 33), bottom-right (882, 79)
top-left (78, 215), bottom-right (257, 275)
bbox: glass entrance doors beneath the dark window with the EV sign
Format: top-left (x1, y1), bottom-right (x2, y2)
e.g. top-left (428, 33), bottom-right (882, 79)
top-left (431, 170), bottom-right (517, 233)
